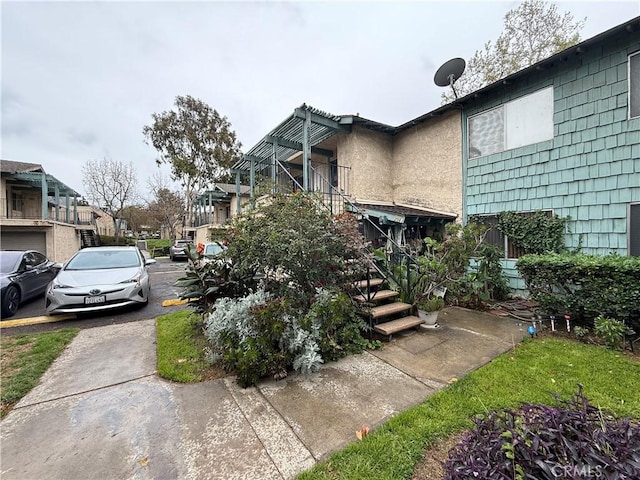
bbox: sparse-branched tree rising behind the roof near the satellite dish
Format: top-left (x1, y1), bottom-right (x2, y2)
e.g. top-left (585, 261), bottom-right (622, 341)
top-left (442, 0), bottom-right (586, 104)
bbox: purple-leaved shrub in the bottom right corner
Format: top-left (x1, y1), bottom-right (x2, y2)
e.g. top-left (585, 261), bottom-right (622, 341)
top-left (445, 386), bottom-right (640, 480)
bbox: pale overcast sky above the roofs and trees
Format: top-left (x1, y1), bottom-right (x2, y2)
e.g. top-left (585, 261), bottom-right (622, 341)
top-left (0, 0), bottom-right (640, 202)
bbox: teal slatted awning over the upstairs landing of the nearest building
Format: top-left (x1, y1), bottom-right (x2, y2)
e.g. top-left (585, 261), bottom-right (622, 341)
top-left (232, 104), bottom-right (353, 171)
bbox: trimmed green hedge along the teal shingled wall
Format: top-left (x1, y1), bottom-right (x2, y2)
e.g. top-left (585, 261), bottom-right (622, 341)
top-left (516, 254), bottom-right (640, 326)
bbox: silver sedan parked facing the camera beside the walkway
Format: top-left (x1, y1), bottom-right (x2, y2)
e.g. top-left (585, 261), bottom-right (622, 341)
top-left (45, 247), bottom-right (156, 315)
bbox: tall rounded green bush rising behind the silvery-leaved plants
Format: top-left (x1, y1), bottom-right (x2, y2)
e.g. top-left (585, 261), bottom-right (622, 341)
top-left (227, 192), bottom-right (368, 308)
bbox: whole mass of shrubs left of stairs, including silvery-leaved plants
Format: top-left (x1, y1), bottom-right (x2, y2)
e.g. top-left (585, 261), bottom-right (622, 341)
top-left (180, 193), bottom-right (375, 386)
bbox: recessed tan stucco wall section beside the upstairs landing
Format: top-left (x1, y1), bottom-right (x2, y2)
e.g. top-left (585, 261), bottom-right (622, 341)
top-left (338, 126), bottom-right (393, 202)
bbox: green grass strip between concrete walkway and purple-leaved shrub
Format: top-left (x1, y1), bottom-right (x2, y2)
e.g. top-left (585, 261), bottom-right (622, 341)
top-left (299, 339), bottom-right (640, 480)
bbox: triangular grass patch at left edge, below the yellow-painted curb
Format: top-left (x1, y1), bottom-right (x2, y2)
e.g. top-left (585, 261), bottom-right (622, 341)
top-left (0, 328), bottom-right (80, 418)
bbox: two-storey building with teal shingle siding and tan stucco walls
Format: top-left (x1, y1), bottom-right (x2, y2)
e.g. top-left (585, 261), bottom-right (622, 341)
top-left (234, 17), bottom-right (640, 289)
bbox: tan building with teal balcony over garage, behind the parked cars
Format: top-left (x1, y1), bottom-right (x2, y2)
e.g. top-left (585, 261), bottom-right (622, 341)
top-left (0, 160), bottom-right (96, 262)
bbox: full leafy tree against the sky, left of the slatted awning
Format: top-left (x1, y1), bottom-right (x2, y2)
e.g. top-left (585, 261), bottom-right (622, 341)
top-left (142, 95), bottom-right (241, 225)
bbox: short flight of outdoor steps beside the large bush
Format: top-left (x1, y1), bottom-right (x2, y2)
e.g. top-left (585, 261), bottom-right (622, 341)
top-left (353, 278), bottom-right (423, 340)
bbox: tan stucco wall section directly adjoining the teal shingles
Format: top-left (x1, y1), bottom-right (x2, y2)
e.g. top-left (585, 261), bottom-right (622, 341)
top-left (392, 112), bottom-right (462, 217)
